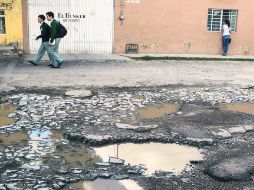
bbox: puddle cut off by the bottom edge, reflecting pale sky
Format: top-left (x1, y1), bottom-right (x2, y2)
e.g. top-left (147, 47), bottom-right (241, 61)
top-left (67, 179), bottom-right (142, 190)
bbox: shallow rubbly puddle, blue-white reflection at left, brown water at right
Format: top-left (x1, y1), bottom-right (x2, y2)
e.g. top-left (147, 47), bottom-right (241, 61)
top-left (29, 130), bottom-right (102, 168)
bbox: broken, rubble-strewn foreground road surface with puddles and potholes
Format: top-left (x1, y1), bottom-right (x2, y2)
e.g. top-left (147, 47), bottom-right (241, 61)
top-left (0, 86), bottom-right (254, 190)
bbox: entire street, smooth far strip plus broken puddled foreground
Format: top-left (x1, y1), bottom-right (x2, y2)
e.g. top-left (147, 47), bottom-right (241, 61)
top-left (0, 59), bottom-right (254, 190)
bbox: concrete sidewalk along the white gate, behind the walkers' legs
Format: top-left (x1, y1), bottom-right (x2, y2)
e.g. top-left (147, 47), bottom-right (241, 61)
top-left (23, 53), bottom-right (131, 62)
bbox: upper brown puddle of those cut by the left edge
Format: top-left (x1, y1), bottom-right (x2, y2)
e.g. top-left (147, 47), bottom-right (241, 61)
top-left (0, 104), bottom-right (17, 127)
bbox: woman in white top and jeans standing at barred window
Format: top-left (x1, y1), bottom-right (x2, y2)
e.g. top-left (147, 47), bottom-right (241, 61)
top-left (222, 20), bottom-right (231, 56)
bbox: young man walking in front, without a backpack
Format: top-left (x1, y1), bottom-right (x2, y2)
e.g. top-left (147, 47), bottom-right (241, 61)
top-left (29, 15), bottom-right (54, 66)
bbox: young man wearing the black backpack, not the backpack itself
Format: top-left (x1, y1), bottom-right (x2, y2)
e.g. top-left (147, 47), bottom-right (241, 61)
top-left (46, 12), bottom-right (64, 68)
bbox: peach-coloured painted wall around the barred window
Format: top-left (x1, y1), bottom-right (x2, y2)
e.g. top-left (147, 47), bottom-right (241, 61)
top-left (115, 0), bottom-right (254, 55)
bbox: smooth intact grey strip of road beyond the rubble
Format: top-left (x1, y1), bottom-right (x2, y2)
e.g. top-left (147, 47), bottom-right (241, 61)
top-left (0, 54), bottom-right (254, 87)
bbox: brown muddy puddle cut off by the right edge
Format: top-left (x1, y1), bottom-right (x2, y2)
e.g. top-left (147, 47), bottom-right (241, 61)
top-left (216, 103), bottom-right (254, 115)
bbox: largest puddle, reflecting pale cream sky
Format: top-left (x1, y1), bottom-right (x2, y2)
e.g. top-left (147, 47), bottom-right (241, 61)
top-left (95, 143), bottom-right (202, 175)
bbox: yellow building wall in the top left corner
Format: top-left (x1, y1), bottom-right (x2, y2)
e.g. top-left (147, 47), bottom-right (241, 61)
top-left (0, 0), bottom-right (23, 47)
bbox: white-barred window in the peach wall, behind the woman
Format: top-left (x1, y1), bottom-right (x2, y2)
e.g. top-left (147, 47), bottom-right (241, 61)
top-left (207, 9), bottom-right (238, 32)
